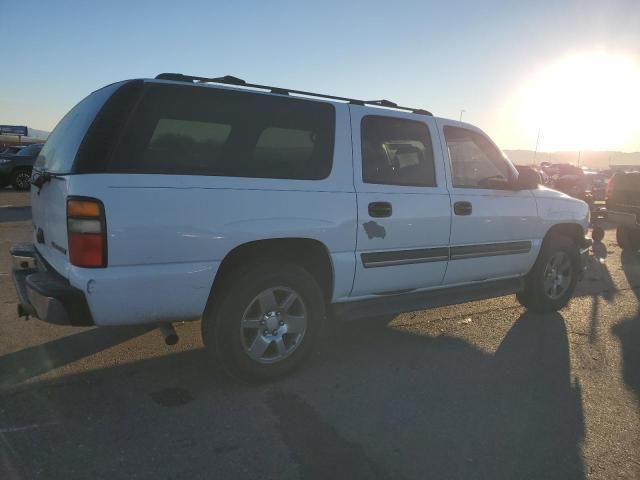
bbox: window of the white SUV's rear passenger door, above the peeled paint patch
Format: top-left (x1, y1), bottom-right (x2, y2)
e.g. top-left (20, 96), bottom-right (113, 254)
top-left (361, 116), bottom-right (436, 187)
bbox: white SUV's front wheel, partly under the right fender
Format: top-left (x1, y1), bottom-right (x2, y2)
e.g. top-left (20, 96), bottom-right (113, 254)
top-left (516, 235), bottom-right (580, 313)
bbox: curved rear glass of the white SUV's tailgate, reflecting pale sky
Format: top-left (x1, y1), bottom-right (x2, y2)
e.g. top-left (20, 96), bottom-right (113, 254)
top-left (35, 83), bottom-right (122, 173)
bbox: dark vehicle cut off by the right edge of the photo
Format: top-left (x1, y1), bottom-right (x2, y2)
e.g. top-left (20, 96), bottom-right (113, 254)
top-left (605, 172), bottom-right (640, 250)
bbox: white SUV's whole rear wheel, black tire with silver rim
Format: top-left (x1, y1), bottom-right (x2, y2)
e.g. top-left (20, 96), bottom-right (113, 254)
top-left (202, 262), bottom-right (325, 382)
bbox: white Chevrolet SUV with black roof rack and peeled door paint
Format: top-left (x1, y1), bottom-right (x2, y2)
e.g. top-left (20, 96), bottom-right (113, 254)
top-left (12, 74), bottom-right (589, 380)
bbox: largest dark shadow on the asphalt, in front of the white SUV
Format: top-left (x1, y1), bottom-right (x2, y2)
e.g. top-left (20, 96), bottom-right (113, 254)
top-left (0, 313), bottom-right (584, 480)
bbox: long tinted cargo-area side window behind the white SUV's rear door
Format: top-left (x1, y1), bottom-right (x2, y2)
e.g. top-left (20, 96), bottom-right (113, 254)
top-left (109, 85), bottom-right (335, 180)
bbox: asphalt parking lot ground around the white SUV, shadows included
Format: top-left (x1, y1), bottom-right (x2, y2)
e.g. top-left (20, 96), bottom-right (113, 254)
top-left (0, 189), bottom-right (640, 480)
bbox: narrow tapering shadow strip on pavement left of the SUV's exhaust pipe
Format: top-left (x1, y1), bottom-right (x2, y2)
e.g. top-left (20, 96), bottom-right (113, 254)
top-left (0, 326), bottom-right (150, 392)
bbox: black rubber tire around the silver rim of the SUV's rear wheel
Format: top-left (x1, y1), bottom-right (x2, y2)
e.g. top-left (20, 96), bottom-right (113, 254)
top-left (203, 263), bottom-right (325, 382)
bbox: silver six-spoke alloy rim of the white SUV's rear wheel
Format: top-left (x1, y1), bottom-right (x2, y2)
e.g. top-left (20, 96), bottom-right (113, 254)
top-left (240, 287), bottom-right (307, 364)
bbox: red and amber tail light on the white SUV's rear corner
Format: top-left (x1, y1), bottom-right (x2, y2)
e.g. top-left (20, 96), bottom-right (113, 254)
top-left (67, 197), bottom-right (107, 268)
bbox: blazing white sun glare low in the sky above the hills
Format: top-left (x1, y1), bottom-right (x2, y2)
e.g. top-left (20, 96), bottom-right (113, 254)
top-left (512, 52), bottom-right (640, 151)
